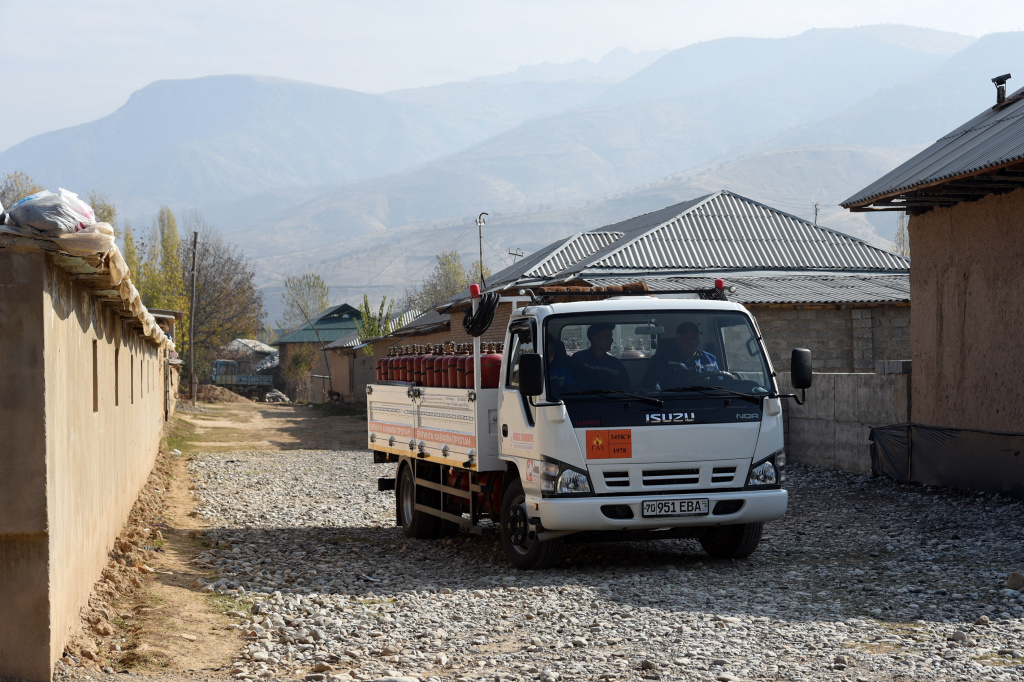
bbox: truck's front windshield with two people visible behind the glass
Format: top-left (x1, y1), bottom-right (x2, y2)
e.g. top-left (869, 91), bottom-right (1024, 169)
top-left (544, 310), bottom-right (772, 400)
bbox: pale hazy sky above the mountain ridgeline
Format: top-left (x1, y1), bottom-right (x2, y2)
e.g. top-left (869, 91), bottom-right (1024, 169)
top-left (0, 0), bottom-right (1024, 150)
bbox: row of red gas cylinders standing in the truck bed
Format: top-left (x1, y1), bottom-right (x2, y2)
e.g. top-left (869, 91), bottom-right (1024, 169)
top-left (377, 343), bottom-right (504, 388)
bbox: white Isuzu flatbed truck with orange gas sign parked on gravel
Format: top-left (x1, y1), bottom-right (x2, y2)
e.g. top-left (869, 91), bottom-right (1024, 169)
top-left (367, 290), bottom-right (811, 568)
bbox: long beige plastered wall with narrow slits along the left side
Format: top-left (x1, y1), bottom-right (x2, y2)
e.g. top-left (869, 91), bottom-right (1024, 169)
top-left (0, 250), bottom-right (166, 680)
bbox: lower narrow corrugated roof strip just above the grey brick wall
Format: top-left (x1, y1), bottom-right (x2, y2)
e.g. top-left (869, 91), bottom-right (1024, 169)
top-left (587, 273), bottom-right (910, 304)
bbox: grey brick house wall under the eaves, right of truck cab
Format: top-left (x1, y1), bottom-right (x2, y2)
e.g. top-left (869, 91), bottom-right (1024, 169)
top-left (746, 304), bottom-right (910, 372)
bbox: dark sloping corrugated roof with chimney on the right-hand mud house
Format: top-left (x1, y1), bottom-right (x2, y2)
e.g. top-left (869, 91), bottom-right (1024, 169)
top-left (841, 88), bottom-right (1024, 208)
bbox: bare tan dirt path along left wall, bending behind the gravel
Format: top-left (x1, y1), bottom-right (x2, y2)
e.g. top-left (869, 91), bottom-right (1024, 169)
top-left (55, 402), bottom-right (366, 680)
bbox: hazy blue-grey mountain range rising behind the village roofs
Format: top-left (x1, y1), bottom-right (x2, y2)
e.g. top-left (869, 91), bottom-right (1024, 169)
top-left (0, 26), bottom-right (1024, 315)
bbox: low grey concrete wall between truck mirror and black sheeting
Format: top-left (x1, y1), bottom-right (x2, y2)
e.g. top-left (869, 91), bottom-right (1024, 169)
top-left (778, 372), bottom-right (911, 473)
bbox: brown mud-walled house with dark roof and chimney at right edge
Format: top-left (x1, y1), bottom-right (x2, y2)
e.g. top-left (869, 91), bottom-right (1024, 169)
top-left (842, 75), bottom-right (1024, 497)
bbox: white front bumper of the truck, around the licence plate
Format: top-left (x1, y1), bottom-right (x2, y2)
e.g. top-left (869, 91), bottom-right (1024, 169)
top-left (526, 489), bottom-right (790, 531)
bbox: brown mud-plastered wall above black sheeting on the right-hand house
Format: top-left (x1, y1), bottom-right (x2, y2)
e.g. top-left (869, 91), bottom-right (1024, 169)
top-left (909, 189), bottom-right (1024, 432)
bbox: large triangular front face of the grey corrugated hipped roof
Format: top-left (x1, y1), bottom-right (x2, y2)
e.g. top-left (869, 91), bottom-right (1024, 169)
top-left (573, 189), bottom-right (909, 276)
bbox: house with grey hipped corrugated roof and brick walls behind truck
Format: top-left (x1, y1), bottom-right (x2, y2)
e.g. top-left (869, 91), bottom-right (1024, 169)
top-left (375, 189), bottom-right (910, 372)
